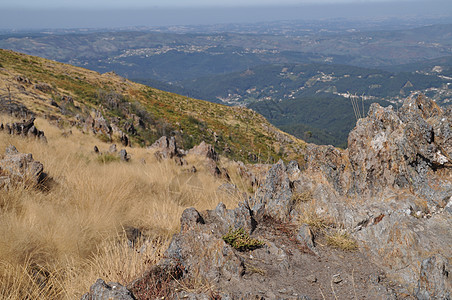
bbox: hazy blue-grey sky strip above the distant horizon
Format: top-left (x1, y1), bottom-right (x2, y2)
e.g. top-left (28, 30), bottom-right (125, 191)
top-left (0, 0), bottom-right (452, 30)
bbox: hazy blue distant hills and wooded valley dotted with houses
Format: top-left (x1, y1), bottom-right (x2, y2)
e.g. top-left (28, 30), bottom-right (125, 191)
top-left (0, 22), bottom-right (452, 147)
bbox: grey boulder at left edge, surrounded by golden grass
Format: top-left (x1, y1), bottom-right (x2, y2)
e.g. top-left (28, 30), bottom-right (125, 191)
top-left (0, 146), bottom-right (44, 189)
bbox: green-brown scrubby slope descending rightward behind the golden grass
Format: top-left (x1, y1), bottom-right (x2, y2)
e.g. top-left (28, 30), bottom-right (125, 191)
top-left (0, 50), bottom-right (304, 161)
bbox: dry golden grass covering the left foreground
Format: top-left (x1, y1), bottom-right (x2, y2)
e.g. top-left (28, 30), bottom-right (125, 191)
top-left (0, 116), bottom-right (244, 299)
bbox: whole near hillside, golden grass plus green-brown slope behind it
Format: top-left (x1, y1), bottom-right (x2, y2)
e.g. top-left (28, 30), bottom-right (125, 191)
top-left (0, 50), bottom-right (305, 299)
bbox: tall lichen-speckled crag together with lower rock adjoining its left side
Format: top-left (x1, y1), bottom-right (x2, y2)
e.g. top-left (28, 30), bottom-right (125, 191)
top-left (305, 97), bottom-right (452, 207)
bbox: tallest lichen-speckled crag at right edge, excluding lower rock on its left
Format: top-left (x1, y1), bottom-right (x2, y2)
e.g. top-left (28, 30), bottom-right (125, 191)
top-left (348, 97), bottom-right (452, 206)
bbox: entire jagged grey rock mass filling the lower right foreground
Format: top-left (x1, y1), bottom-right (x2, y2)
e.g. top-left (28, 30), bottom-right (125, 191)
top-left (84, 97), bottom-right (452, 299)
